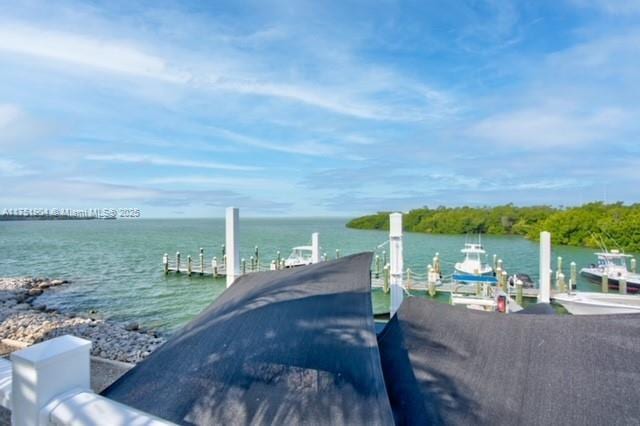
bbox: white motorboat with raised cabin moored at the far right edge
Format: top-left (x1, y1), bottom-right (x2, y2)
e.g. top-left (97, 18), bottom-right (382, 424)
top-left (580, 250), bottom-right (640, 292)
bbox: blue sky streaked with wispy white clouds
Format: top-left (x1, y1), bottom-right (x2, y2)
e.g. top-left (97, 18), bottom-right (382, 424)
top-left (0, 0), bottom-right (640, 217)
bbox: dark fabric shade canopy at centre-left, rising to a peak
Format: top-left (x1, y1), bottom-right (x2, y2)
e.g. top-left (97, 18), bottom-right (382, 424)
top-left (103, 253), bottom-right (393, 425)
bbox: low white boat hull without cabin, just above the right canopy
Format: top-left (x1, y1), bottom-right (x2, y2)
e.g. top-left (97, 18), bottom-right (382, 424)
top-left (552, 292), bottom-right (640, 315)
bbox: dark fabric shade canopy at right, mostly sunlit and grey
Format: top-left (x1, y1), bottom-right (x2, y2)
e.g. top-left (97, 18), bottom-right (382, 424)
top-left (378, 297), bottom-right (640, 425)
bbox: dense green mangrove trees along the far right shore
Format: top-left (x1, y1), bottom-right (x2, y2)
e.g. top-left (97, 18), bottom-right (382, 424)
top-left (347, 202), bottom-right (640, 252)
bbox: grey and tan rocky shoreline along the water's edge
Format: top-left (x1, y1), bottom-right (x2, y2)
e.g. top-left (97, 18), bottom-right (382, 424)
top-left (0, 277), bottom-right (164, 363)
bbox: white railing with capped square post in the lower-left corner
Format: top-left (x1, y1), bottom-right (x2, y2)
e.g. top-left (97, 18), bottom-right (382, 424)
top-left (0, 335), bottom-right (173, 426)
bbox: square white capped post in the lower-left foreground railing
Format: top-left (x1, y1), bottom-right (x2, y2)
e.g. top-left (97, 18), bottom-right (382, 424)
top-left (11, 335), bottom-right (91, 426)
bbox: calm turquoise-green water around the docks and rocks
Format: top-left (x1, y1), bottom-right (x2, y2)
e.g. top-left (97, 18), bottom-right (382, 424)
top-left (0, 218), bottom-right (632, 331)
